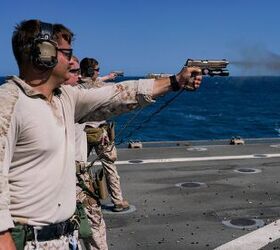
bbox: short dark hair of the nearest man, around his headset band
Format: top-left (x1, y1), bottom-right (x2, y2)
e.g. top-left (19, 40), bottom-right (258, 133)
top-left (12, 19), bottom-right (74, 67)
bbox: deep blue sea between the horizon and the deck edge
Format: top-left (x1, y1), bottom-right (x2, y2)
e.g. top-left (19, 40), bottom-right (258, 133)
top-left (1, 76), bottom-right (280, 142)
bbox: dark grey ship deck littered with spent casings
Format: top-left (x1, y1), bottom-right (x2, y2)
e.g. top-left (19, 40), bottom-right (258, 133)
top-left (88, 139), bottom-right (280, 250)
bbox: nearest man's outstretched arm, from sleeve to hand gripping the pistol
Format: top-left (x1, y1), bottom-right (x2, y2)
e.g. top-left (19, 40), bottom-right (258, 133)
top-left (73, 67), bottom-right (202, 123)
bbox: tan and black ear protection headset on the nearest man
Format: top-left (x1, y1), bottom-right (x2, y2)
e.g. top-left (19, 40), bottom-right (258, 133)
top-left (31, 22), bottom-right (57, 69)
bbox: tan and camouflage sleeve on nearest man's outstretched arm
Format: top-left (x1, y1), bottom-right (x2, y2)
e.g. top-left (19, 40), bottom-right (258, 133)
top-left (75, 79), bottom-right (154, 122)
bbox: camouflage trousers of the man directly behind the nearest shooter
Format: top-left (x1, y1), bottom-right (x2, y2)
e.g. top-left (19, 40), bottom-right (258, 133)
top-left (76, 163), bottom-right (108, 250)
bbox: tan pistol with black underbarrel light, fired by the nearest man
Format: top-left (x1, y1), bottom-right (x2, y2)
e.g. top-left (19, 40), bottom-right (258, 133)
top-left (185, 59), bottom-right (229, 76)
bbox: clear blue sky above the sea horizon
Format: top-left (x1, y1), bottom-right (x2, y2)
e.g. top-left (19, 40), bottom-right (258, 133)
top-left (0, 0), bottom-right (280, 76)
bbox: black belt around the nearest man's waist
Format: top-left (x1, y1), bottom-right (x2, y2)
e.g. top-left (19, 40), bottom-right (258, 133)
top-left (13, 219), bottom-right (75, 241)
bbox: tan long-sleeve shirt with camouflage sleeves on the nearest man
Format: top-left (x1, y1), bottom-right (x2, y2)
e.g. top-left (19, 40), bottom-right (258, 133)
top-left (0, 77), bottom-right (153, 231)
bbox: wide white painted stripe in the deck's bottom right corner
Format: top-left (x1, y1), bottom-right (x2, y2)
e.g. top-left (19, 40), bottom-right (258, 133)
top-left (214, 220), bottom-right (280, 250)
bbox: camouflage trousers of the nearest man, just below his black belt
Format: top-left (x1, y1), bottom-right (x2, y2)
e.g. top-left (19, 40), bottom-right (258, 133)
top-left (24, 231), bottom-right (82, 250)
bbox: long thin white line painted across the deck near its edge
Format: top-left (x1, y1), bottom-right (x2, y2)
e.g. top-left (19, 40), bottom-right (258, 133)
top-left (89, 154), bottom-right (280, 165)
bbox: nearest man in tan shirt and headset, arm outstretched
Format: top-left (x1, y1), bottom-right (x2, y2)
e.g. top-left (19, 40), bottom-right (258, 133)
top-left (0, 20), bottom-right (202, 250)
